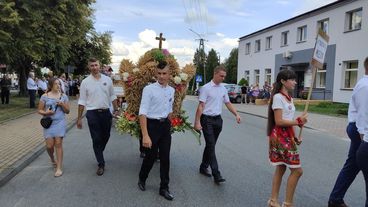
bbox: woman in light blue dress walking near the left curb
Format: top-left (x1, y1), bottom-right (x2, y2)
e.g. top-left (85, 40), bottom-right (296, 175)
top-left (38, 78), bottom-right (70, 177)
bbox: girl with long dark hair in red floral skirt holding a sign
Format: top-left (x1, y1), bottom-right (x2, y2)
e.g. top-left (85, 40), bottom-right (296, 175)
top-left (267, 69), bottom-right (307, 207)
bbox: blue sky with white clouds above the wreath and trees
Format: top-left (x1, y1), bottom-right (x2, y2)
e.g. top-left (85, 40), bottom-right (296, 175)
top-left (94, 0), bottom-right (335, 71)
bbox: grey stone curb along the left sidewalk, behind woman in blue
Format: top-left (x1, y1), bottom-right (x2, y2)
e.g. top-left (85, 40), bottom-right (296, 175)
top-left (0, 115), bottom-right (81, 187)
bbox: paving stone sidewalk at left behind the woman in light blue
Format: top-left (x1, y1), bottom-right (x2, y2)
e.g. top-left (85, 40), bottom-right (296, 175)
top-left (0, 99), bottom-right (78, 187)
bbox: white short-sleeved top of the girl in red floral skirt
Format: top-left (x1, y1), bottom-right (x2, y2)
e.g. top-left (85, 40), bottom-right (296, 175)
top-left (272, 93), bottom-right (295, 121)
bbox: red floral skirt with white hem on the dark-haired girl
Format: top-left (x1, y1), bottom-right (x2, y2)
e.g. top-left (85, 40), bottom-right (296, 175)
top-left (269, 126), bottom-right (300, 168)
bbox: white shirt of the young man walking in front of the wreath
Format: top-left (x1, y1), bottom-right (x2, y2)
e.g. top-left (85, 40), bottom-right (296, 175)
top-left (139, 82), bottom-right (175, 119)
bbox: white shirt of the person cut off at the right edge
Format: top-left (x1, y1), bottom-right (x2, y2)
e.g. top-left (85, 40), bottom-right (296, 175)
top-left (349, 75), bottom-right (368, 142)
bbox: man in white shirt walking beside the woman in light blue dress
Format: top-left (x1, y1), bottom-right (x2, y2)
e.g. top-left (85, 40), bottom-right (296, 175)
top-left (77, 58), bottom-right (119, 176)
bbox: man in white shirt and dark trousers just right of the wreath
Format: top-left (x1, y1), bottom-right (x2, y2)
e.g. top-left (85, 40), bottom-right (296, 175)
top-left (194, 65), bottom-right (240, 184)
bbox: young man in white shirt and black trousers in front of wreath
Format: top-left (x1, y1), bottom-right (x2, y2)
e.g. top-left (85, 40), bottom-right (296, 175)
top-left (138, 61), bottom-right (175, 200)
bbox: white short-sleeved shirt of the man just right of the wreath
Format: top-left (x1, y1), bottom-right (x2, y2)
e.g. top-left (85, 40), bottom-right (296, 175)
top-left (199, 80), bottom-right (230, 116)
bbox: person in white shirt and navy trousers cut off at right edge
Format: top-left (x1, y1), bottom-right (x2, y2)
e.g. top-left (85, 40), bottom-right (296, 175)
top-left (328, 57), bottom-right (368, 207)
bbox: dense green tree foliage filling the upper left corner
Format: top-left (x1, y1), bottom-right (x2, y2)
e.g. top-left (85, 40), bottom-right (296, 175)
top-left (0, 0), bottom-right (111, 93)
